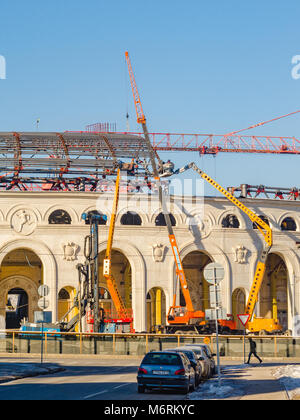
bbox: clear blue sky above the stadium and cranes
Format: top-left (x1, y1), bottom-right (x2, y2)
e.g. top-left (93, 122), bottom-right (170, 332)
top-left (0, 0), bottom-right (300, 195)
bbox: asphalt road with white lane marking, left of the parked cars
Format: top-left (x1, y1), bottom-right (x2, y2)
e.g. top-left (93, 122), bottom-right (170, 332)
top-left (0, 359), bottom-right (190, 401)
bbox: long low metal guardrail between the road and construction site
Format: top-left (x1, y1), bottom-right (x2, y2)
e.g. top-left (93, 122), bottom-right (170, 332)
top-left (0, 330), bottom-right (300, 358)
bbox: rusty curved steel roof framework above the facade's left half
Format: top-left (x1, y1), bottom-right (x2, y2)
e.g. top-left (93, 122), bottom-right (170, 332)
top-left (0, 132), bottom-right (155, 191)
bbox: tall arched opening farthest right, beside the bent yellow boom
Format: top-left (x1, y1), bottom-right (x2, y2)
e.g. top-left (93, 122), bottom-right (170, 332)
top-left (258, 254), bottom-right (288, 331)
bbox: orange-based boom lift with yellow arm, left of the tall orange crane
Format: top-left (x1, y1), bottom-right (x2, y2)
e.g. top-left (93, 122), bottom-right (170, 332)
top-left (103, 169), bottom-right (133, 332)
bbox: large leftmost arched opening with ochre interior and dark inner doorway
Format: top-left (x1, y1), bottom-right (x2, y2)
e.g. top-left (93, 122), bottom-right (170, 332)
top-left (0, 248), bottom-right (43, 329)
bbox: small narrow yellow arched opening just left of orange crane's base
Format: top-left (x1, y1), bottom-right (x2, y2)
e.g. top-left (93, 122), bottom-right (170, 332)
top-left (147, 287), bottom-right (166, 331)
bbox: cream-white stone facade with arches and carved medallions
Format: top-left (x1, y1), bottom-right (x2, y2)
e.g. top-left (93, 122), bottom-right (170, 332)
top-left (0, 191), bottom-right (300, 331)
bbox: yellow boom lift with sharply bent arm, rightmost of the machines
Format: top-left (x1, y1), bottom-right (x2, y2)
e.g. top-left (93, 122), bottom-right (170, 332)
top-left (166, 162), bottom-right (282, 333)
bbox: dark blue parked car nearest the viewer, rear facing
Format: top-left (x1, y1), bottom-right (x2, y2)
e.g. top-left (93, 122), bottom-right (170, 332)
top-left (137, 351), bottom-right (196, 394)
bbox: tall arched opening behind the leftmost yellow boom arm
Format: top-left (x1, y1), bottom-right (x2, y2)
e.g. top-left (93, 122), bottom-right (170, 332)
top-left (99, 249), bottom-right (132, 318)
